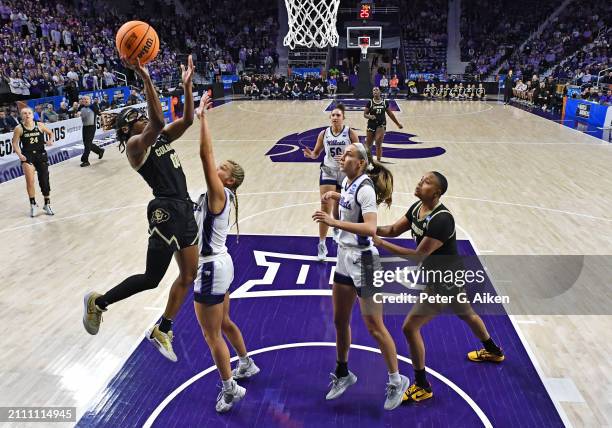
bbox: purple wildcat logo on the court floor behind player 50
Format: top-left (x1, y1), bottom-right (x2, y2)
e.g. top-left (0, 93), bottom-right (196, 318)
top-left (266, 127), bottom-right (446, 163)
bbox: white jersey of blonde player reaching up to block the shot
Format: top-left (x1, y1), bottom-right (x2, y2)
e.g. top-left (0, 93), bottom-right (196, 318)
top-left (195, 188), bottom-right (234, 257)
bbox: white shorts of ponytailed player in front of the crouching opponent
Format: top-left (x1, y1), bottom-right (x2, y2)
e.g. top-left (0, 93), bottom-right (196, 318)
top-left (334, 246), bottom-right (382, 297)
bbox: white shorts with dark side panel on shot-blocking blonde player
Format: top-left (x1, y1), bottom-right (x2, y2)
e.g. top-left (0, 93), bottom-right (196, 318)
top-left (193, 253), bottom-right (234, 306)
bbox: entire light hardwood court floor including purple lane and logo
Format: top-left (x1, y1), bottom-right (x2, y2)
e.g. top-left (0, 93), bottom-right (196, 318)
top-left (0, 100), bottom-right (612, 427)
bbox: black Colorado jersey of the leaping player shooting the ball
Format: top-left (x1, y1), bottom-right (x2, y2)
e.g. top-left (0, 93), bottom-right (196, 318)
top-left (136, 134), bottom-right (189, 199)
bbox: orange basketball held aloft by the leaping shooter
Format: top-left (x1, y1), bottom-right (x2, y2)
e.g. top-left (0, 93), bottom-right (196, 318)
top-left (115, 21), bottom-right (159, 64)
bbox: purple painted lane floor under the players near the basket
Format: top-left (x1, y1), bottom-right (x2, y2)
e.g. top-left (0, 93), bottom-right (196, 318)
top-left (78, 235), bottom-right (562, 428)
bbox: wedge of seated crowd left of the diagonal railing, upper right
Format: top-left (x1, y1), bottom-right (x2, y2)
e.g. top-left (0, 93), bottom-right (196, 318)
top-left (461, 0), bottom-right (559, 75)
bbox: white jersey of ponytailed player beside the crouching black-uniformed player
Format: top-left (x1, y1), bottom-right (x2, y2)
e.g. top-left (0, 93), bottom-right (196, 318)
top-left (338, 174), bottom-right (377, 249)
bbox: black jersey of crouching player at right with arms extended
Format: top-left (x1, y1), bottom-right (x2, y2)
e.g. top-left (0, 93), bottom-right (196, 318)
top-left (406, 201), bottom-right (458, 256)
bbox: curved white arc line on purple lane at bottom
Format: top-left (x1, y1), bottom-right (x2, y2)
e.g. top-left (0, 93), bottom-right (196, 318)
top-left (143, 342), bottom-right (493, 428)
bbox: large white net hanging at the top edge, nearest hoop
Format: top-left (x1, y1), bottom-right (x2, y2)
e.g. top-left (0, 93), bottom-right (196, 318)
top-left (283, 0), bottom-right (340, 49)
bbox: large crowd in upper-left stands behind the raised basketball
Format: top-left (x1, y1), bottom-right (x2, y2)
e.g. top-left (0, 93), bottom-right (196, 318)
top-left (0, 0), bottom-right (278, 103)
